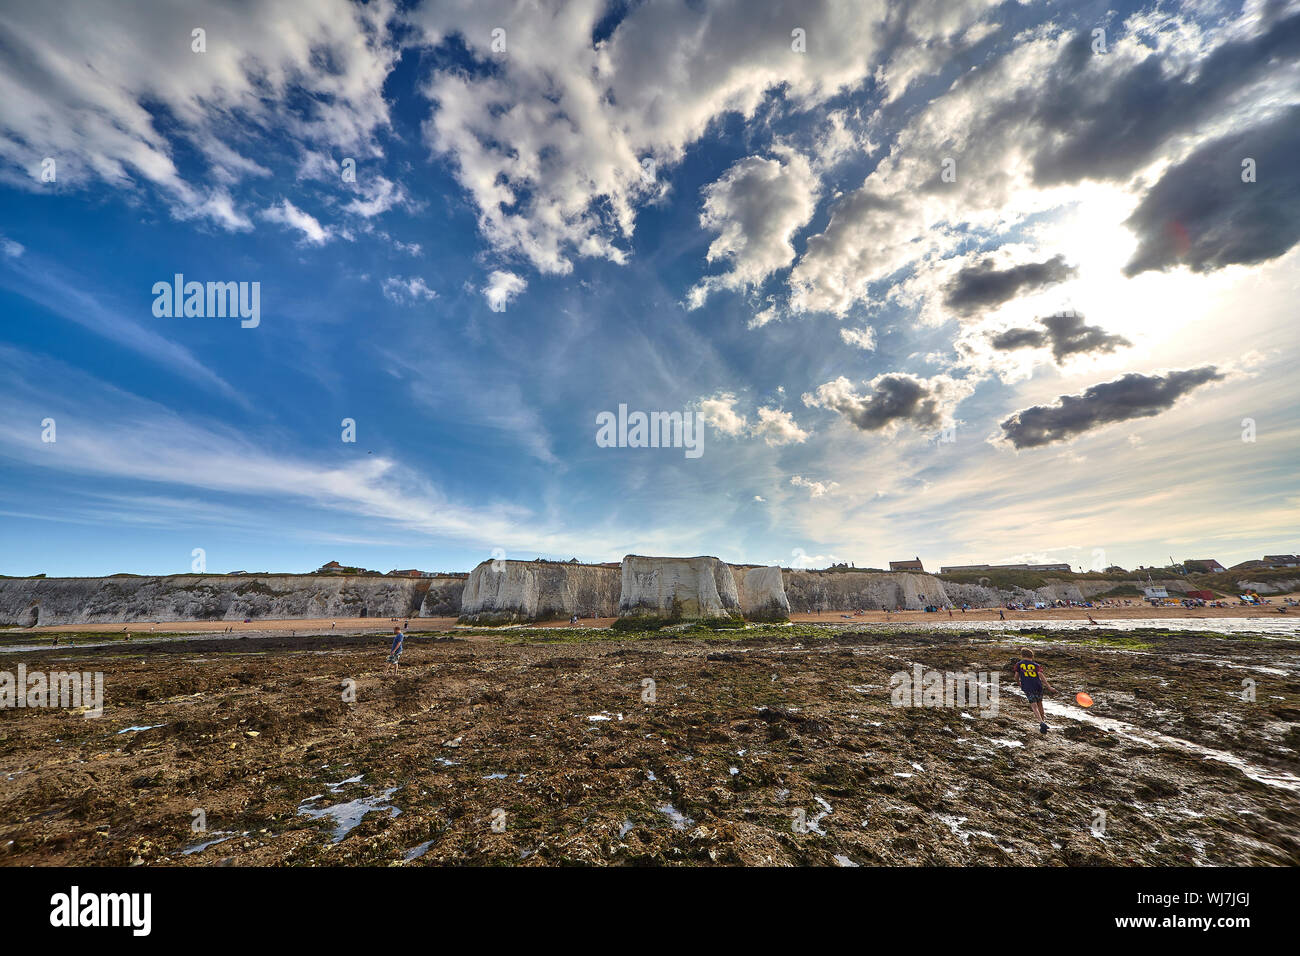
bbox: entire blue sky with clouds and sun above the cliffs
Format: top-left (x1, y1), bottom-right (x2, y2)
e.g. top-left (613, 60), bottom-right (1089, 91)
top-left (0, 0), bottom-right (1300, 575)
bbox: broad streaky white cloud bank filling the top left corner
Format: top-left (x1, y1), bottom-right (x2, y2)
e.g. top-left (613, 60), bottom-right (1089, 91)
top-left (0, 0), bottom-right (400, 230)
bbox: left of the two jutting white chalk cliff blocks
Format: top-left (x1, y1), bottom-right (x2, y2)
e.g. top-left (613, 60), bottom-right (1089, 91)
top-left (460, 561), bottom-right (619, 623)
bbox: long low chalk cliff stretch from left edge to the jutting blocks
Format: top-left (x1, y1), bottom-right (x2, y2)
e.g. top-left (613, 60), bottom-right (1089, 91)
top-left (0, 575), bottom-right (464, 627)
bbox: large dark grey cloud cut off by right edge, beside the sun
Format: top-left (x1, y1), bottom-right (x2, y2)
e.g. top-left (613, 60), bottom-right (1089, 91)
top-left (1125, 107), bottom-right (1300, 276)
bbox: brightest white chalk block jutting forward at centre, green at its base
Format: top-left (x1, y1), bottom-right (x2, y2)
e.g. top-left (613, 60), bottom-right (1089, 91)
top-left (619, 554), bottom-right (741, 618)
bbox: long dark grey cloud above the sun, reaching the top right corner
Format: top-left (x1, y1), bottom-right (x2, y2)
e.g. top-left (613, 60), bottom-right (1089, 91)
top-left (1024, 14), bottom-right (1300, 186)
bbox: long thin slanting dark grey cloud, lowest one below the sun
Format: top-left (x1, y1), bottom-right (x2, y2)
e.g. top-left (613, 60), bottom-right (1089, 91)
top-left (1002, 365), bottom-right (1225, 449)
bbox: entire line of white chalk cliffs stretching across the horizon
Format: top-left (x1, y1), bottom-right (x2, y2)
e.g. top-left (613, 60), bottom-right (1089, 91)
top-left (10, 564), bottom-right (1274, 627)
